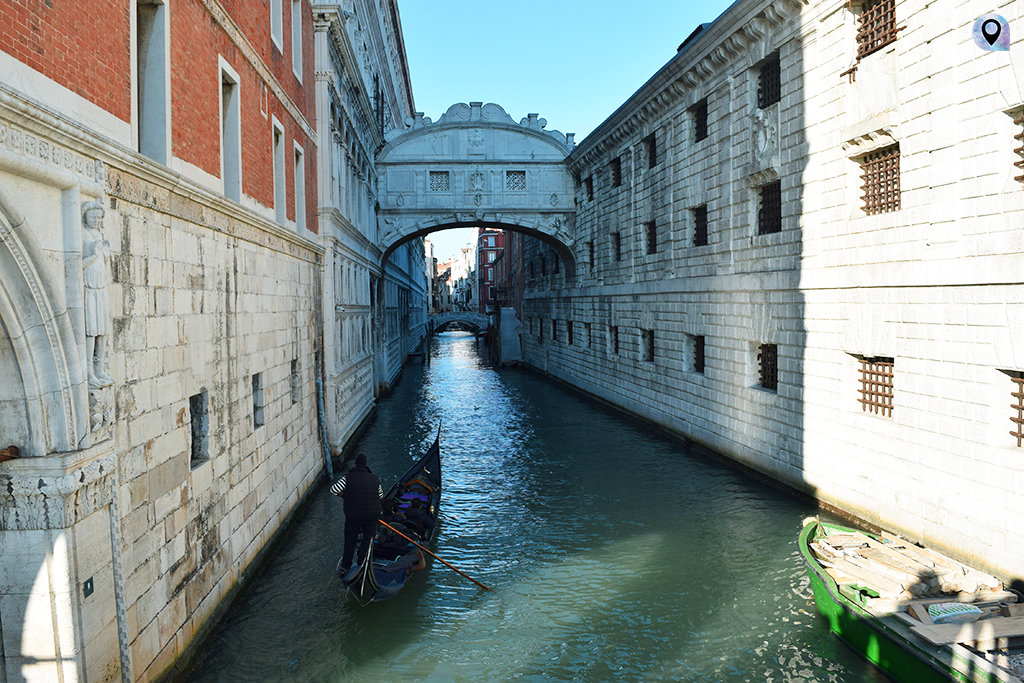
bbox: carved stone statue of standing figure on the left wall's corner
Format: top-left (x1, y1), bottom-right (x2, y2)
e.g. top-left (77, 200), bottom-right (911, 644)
top-left (82, 202), bottom-right (114, 389)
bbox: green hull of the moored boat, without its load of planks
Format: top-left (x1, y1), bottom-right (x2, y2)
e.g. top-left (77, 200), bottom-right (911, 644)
top-left (800, 519), bottom-right (1021, 683)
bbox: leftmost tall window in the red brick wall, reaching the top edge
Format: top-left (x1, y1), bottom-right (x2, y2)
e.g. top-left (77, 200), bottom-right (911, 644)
top-left (135, 0), bottom-right (169, 164)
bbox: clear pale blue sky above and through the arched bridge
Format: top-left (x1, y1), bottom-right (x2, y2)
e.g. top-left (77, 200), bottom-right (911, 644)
top-left (398, 0), bottom-right (732, 260)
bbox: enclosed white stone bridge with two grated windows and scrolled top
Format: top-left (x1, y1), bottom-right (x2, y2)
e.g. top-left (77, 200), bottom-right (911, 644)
top-left (377, 102), bottom-right (577, 278)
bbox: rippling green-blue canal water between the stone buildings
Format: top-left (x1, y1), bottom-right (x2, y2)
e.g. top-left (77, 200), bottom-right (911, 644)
top-left (190, 333), bottom-right (884, 682)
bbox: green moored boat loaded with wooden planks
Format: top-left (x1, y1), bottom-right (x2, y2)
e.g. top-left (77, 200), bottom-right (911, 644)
top-left (799, 519), bottom-right (1024, 683)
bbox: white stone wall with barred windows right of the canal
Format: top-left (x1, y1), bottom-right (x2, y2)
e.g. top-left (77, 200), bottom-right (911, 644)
top-left (523, 0), bottom-right (1024, 578)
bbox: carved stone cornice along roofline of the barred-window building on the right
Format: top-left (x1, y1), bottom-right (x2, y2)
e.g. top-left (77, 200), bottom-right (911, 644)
top-left (566, 0), bottom-right (809, 173)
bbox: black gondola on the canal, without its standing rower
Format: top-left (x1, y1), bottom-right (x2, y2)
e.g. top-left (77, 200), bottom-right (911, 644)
top-left (342, 427), bottom-right (441, 605)
